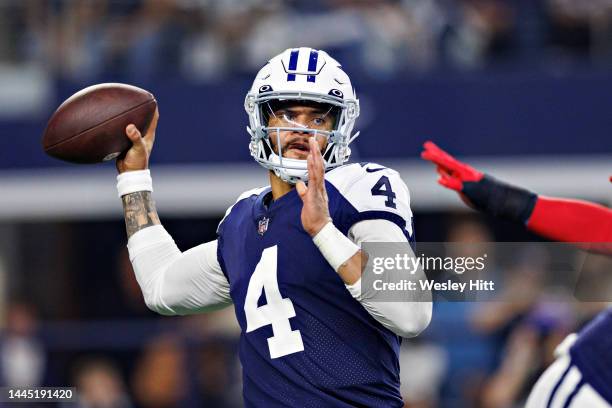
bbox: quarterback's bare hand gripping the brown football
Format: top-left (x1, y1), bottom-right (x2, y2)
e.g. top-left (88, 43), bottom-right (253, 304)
top-left (117, 109), bottom-right (159, 173)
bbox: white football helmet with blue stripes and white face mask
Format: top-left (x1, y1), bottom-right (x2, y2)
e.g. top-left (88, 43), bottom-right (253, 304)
top-left (244, 48), bottom-right (359, 184)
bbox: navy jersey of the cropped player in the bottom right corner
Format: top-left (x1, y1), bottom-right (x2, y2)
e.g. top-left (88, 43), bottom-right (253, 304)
top-left (570, 308), bottom-right (612, 404)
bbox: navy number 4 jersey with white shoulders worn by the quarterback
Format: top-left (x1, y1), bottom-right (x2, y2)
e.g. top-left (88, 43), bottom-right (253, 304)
top-left (218, 164), bottom-right (413, 407)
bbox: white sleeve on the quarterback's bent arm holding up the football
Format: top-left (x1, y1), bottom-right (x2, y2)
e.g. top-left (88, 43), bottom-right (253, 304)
top-left (128, 225), bottom-right (232, 315)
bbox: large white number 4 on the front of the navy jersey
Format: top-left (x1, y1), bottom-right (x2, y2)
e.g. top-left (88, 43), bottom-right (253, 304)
top-left (244, 245), bottom-right (304, 358)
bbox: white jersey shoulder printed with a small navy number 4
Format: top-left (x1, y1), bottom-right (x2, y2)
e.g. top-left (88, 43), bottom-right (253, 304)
top-left (325, 162), bottom-right (412, 233)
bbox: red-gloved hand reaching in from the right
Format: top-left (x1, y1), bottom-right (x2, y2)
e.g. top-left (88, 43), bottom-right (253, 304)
top-left (421, 141), bottom-right (484, 192)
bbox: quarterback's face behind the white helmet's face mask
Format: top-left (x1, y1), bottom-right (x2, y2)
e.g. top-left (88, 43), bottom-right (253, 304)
top-left (268, 103), bottom-right (335, 160)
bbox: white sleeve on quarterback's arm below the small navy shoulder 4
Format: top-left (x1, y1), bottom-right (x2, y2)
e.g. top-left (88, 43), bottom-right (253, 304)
top-left (346, 219), bottom-right (432, 337)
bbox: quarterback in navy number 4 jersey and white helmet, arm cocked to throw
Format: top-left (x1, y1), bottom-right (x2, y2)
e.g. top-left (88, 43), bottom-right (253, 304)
top-left (117, 48), bottom-right (432, 407)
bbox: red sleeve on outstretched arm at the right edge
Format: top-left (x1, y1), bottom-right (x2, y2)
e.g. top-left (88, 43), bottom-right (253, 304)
top-left (527, 196), bottom-right (612, 253)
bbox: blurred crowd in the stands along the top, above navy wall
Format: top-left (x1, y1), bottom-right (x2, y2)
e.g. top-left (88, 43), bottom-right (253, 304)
top-left (0, 0), bottom-right (612, 81)
